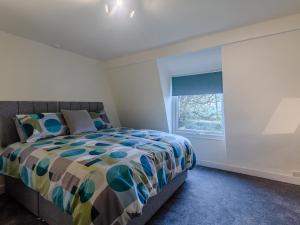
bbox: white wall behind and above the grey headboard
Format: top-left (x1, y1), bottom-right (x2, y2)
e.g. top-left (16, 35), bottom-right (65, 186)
top-left (0, 32), bottom-right (119, 192)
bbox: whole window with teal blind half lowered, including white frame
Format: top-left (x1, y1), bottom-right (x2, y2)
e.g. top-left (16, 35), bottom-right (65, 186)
top-left (172, 72), bottom-right (224, 137)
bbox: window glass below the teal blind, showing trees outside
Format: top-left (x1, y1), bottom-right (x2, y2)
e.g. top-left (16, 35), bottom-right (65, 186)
top-left (178, 94), bottom-right (224, 133)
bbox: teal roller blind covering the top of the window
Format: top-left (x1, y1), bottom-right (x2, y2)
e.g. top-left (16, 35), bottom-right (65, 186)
top-left (172, 72), bottom-right (223, 96)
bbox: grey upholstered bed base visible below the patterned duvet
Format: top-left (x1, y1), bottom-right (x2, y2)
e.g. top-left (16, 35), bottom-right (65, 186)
top-left (5, 171), bottom-right (187, 225)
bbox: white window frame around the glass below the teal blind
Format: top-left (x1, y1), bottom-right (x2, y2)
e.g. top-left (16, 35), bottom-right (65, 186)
top-left (172, 96), bottom-right (225, 140)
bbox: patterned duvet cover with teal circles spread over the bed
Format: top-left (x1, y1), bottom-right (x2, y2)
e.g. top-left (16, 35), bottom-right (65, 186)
top-left (0, 128), bottom-right (196, 225)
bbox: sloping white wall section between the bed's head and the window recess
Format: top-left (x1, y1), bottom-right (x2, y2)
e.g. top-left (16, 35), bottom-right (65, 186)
top-left (107, 61), bottom-right (168, 131)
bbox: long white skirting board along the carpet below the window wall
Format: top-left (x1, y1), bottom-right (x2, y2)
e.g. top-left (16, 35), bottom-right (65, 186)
top-left (197, 160), bottom-right (300, 185)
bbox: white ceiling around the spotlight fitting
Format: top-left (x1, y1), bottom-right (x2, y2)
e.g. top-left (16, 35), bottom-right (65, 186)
top-left (0, 0), bottom-right (300, 60)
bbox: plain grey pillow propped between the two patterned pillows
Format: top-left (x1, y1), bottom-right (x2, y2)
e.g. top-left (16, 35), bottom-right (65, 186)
top-left (61, 110), bottom-right (97, 134)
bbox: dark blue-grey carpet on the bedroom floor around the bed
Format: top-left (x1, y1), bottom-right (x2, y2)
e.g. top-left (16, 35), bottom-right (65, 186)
top-left (0, 167), bottom-right (300, 225)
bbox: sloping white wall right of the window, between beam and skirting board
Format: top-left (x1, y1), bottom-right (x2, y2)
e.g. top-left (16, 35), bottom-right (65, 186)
top-left (223, 31), bottom-right (300, 175)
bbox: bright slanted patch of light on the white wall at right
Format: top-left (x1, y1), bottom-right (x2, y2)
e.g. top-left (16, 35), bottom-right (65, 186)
top-left (263, 98), bottom-right (300, 135)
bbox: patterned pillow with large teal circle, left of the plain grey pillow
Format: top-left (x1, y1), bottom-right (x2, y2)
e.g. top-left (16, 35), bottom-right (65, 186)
top-left (15, 113), bottom-right (67, 143)
